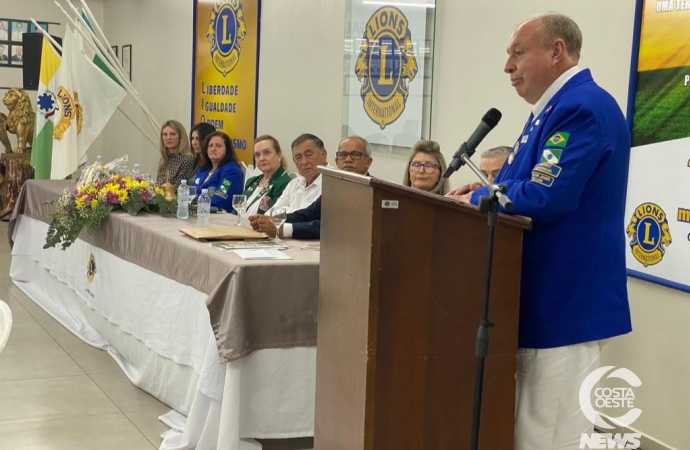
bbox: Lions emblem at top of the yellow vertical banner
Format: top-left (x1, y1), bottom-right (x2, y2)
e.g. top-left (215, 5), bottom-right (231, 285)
top-left (206, 0), bottom-right (247, 76)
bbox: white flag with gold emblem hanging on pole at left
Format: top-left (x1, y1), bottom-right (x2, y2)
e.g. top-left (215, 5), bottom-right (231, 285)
top-left (51, 27), bottom-right (127, 179)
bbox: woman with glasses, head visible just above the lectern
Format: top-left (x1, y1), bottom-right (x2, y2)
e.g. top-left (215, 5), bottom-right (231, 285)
top-left (403, 140), bottom-right (450, 195)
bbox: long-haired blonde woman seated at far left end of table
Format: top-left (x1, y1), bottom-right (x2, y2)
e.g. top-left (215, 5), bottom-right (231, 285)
top-left (156, 120), bottom-right (194, 191)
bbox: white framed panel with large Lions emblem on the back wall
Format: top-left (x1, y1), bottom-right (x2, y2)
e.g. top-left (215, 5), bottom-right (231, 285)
top-left (346, 1), bottom-right (427, 147)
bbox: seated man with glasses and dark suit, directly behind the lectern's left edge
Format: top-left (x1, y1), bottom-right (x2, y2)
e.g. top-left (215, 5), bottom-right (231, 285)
top-left (249, 136), bottom-right (373, 239)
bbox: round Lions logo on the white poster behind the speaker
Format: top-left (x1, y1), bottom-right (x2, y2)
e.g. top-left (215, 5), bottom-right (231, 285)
top-left (625, 203), bottom-right (673, 267)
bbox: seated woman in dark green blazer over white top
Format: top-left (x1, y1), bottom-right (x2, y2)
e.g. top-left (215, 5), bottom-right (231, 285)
top-left (244, 135), bottom-right (291, 216)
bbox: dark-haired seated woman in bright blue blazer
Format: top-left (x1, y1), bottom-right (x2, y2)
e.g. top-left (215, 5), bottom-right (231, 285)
top-left (194, 131), bottom-right (243, 212)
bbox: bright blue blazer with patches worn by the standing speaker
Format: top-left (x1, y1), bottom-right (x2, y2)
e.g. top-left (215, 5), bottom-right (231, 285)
top-left (472, 70), bottom-right (632, 348)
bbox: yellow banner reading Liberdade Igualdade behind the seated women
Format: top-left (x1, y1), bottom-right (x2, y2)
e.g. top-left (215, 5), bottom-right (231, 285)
top-left (192, 0), bottom-right (260, 164)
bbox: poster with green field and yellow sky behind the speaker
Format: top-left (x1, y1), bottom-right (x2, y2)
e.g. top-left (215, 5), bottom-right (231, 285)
top-left (625, 0), bottom-right (690, 291)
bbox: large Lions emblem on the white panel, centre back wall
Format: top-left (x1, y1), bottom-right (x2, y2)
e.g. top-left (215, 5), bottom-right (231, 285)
top-left (355, 6), bottom-right (418, 130)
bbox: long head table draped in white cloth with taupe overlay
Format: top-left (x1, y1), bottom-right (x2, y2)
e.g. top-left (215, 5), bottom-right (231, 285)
top-left (8, 180), bottom-right (319, 450)
